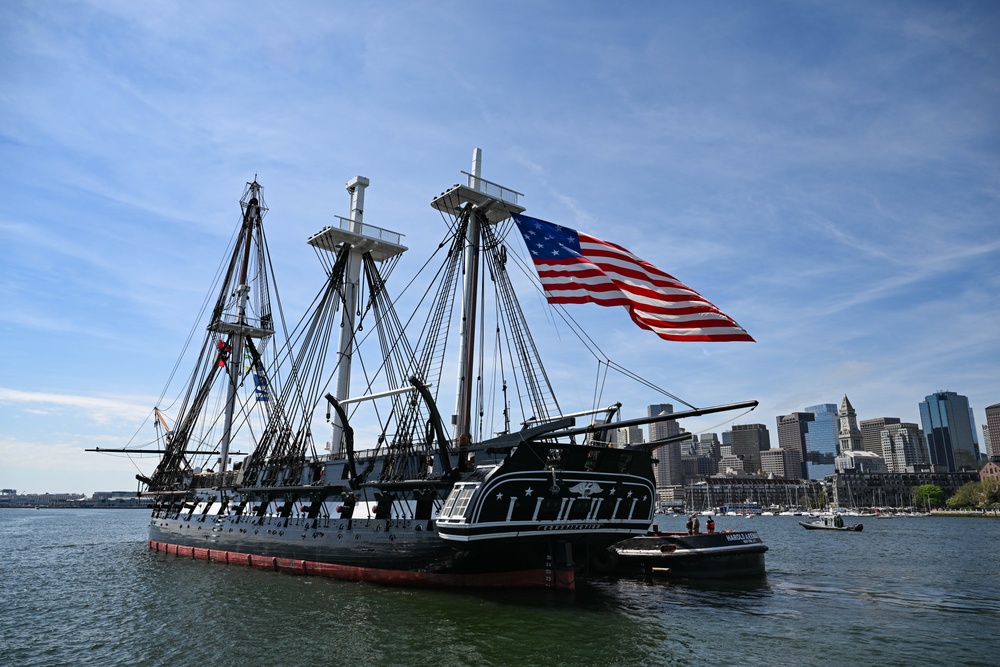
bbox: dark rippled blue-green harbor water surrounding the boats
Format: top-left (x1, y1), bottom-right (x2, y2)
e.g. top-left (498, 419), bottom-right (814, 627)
top-left (0, 509), bottom-right (1000, 667)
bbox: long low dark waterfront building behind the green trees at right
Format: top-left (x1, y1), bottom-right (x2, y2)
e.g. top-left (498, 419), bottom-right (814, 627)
top-left (831, 470), bottom-right (979, 508)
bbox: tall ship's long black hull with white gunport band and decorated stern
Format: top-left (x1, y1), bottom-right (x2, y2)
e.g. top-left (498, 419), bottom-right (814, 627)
top-left (149, 442), bottom-right (655, 588)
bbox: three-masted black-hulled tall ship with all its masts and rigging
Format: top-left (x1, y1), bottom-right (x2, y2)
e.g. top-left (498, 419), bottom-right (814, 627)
top-left (130, 149), bottom-right (756, 589)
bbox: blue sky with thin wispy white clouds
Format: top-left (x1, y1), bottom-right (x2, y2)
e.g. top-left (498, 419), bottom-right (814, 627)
top-left (0, 0), bottom-right (1000, 494)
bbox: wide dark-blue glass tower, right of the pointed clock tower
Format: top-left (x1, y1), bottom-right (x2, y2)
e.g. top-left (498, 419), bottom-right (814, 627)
top-left (920, 391), bottom-right (979, 472)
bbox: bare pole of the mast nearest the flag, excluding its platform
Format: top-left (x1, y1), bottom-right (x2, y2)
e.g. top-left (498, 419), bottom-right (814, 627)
top-left (454, 148), bottom-right (483, 437)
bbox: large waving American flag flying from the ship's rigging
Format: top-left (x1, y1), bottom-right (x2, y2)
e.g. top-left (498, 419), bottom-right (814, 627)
top-left (514, 214), bottom-right (753, 342)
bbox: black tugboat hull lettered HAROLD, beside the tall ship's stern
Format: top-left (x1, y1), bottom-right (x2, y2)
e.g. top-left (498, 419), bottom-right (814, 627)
top-left (608, 531), bottom-right (767, 579)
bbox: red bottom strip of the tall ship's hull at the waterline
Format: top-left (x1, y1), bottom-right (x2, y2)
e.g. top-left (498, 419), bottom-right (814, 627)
top-left (149, 540), bottom-right (576, 591)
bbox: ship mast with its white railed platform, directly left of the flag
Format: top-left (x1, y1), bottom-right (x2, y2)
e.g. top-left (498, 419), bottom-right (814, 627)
top-left (431, 148), bottom-right (524, 438)
